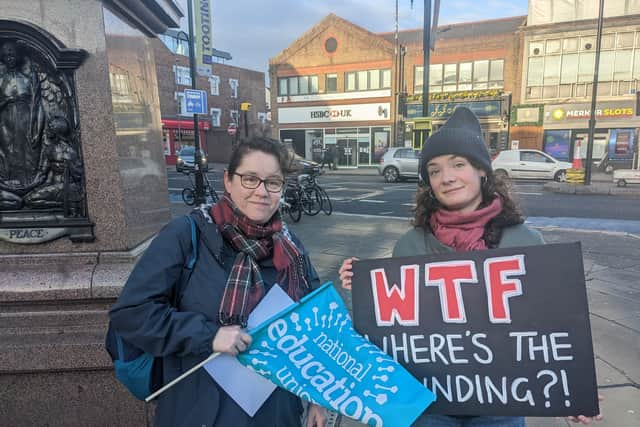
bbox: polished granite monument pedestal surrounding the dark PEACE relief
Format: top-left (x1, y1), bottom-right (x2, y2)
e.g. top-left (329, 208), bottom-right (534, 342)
top-left (0, 0), bottom-right (182, 426)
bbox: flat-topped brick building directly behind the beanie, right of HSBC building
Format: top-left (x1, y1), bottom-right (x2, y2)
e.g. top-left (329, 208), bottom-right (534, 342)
top-left (384, 16), bottom-right (526, 157)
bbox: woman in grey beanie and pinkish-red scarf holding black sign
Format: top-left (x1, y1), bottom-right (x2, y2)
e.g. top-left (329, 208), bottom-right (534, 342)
top-left (340, 107), bottom-right (601, 427)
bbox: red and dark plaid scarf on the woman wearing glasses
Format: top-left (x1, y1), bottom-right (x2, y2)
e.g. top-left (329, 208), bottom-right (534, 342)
top-left (211, 193), bottom-right (308, 327)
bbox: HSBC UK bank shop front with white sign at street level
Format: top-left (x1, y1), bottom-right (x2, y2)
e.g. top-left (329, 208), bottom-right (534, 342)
top-left (278, 103), bottom-right (391, 168)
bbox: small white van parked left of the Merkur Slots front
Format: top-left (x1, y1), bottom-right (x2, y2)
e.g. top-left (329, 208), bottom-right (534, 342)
top-left (491, 150), bottom-right (572, 182)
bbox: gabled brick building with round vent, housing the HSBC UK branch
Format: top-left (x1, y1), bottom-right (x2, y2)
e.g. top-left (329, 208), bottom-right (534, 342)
top-left (269, 14), bottom-right (394, 167)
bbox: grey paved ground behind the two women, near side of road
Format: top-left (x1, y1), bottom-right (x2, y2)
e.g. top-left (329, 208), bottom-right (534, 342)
top-left (291, 213), bottom-right (640, 427)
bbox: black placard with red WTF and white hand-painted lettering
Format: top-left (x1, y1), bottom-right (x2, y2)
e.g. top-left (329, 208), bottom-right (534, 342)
top-left (352, 243), bottom-right (599, 416)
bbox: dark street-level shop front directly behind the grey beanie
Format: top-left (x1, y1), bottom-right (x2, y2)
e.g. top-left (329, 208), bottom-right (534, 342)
top-left (406, 95), bottom-right (509, 154)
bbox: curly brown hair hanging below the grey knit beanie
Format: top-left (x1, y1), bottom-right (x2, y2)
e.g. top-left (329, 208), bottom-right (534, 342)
top-left (411, 159), bottom-right (524, 248)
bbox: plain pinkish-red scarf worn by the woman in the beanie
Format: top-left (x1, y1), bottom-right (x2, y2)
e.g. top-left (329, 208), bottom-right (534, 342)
top-left (429, 197), bottom-right (502, 252)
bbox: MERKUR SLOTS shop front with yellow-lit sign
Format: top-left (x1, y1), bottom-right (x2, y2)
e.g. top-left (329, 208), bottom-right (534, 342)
top-left (542, 101), bottom-right (640, 172)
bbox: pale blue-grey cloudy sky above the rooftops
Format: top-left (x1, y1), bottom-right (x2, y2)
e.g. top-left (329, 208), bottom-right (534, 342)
top-left (179, 0), bottom-right (527, 83)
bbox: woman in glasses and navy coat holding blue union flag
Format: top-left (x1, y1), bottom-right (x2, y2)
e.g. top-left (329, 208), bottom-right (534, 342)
top-left (109, 137), bottom-right (326, 427)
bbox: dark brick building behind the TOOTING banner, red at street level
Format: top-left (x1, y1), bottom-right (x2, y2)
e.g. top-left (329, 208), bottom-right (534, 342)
top-left (153, 32), bottom-right (269, 165)
